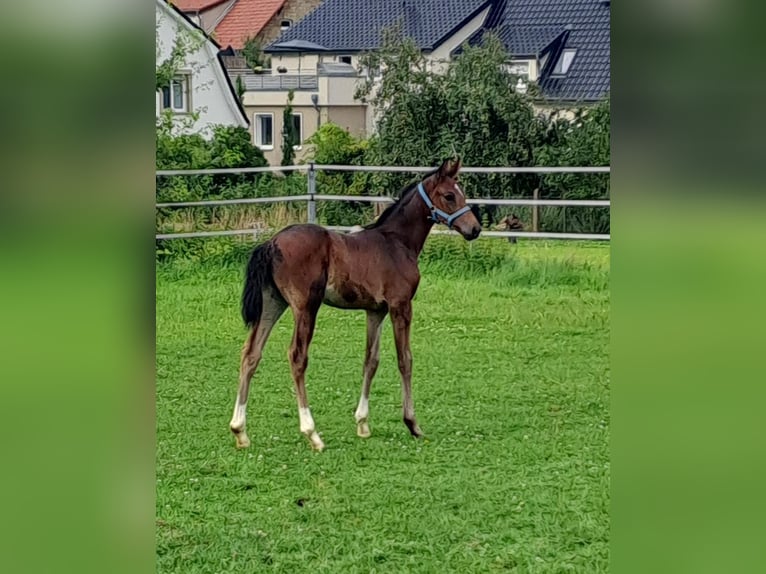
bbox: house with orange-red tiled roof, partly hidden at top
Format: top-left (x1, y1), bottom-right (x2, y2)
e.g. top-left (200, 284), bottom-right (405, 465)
top-left (174, 0), bottom-right (321, 50)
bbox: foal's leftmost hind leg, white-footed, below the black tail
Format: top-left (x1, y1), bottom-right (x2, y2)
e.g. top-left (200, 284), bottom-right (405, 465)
top-left (229, 289), bottom-right (287, 448)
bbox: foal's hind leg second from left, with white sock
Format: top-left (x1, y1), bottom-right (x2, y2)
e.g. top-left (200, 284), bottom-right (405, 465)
top-left (289, 304), bottom-right (324, 451)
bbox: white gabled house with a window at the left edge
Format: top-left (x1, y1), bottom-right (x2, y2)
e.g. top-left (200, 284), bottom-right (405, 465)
top-left (155, 0), bottom-right (249, 137)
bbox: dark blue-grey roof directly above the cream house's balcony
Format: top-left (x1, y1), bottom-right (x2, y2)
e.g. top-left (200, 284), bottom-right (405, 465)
top-left (265, 0), bottom-right (493, 52)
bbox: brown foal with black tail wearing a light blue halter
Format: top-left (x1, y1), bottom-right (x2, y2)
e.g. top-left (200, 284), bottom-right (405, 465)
top-left (229, 160), bottom-right (481, 450)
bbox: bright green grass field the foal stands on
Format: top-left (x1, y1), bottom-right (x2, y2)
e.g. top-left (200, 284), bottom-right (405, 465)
top-left (156, 238), bottom-right (610, 574)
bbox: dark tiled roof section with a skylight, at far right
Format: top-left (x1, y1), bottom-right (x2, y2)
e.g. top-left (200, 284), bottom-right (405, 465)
top-left (462, 0), bottom-right (610, 101)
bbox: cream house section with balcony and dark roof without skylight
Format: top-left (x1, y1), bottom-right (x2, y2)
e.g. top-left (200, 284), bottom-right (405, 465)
top-left (234, 0), bottom-right (497, 164)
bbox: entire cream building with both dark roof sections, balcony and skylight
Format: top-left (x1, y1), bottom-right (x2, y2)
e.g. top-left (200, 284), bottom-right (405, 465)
top-left (229, 0), bottom-right (611, 163)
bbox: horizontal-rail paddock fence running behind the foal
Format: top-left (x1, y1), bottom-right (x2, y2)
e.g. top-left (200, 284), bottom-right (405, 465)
top-left (155, 163), bottom-right (611, 240)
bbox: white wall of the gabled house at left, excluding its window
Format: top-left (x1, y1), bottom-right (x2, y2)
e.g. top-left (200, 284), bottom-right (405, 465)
top-left (155, 0), bottom-right (248, 138)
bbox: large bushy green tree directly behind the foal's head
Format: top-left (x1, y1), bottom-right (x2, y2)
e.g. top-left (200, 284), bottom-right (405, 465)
top-left (356, 27), bottom-right (539, 222)
